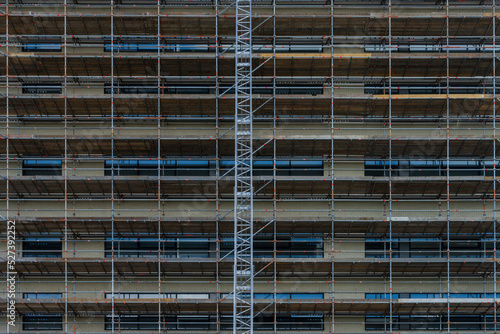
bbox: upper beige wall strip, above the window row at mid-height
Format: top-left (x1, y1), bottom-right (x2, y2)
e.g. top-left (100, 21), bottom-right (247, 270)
top-left (2, 120), bottom-right (493, 138)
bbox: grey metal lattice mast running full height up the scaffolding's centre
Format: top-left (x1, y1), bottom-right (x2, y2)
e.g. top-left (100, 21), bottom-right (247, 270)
top-left (233, 0), bottom-right (254, 334)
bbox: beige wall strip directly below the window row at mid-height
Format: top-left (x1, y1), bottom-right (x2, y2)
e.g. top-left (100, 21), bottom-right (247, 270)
top-left (0, 198), bottom-right (493, 221)
